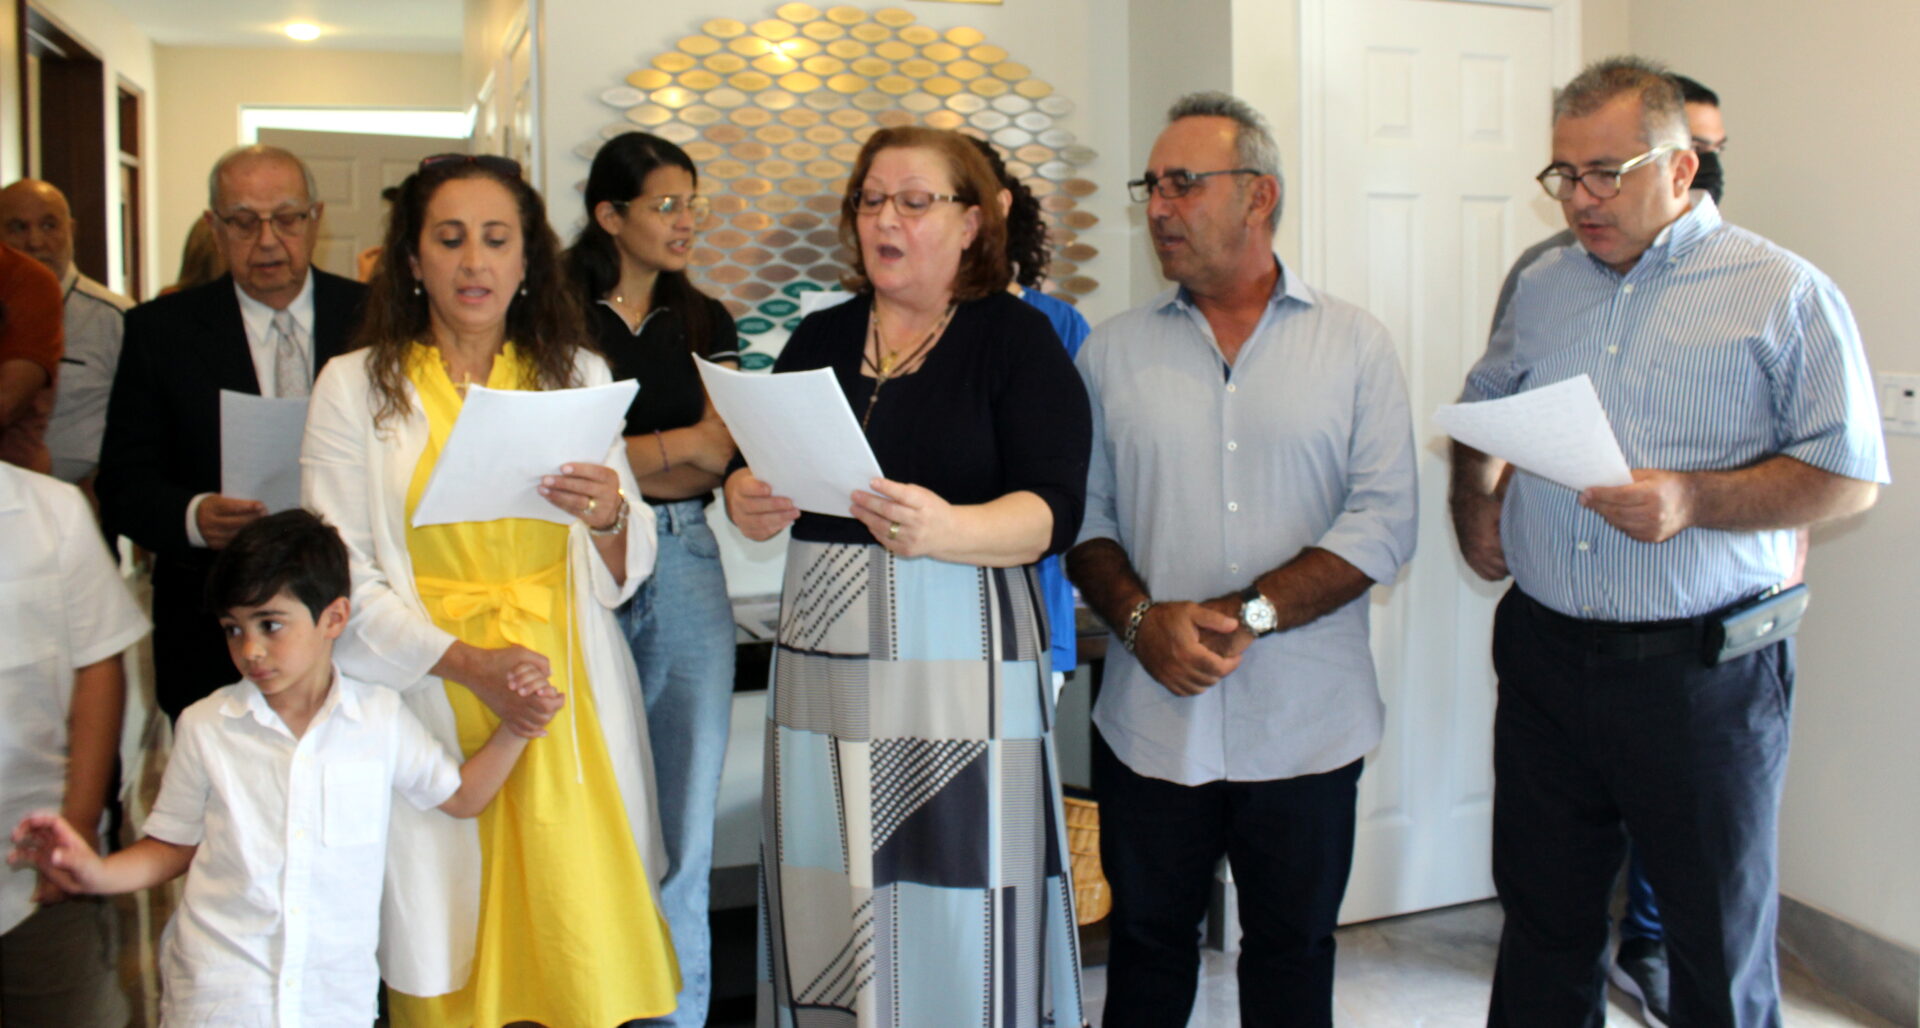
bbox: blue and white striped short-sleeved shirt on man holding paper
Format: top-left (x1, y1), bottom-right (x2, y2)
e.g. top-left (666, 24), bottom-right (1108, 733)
top-left (1461, 198), bottom-right (1887, 621)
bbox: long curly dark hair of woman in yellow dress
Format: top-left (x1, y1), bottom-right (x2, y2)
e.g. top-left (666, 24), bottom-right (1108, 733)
top-left (351, 159), bottom-right (593, 425)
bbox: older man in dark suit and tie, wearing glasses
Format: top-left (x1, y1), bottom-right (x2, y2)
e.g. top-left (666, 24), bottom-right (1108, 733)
top-left (96, 146), bottom-right (365, 715)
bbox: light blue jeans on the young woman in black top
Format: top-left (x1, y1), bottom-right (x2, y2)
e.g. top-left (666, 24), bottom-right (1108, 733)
top-left (620, 500), bottom-right (733, 1026)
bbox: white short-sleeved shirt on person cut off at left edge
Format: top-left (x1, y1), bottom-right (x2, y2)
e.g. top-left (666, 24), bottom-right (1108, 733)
top-left (0, 463), bottom-right (148, 934)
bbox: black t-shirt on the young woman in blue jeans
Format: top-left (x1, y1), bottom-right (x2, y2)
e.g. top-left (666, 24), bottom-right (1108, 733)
top-left (588, 296), bottom-right (739, 436)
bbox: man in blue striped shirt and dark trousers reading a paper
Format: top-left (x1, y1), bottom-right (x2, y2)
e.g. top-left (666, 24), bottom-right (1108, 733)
top-left (1452, 58), bottom-right (1887, 1026)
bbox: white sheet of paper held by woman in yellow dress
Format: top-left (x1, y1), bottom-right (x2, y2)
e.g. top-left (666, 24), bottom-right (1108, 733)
top-left (413, 379), bottom-right (639, 528)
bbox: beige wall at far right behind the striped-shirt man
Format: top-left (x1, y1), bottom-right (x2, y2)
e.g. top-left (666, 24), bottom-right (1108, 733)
top-left (1632, 0), bottom-right (1920, 949)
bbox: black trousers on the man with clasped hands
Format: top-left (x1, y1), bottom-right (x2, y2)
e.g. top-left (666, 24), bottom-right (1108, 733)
top-left (1092, 730), bottom-right (1361, 1028)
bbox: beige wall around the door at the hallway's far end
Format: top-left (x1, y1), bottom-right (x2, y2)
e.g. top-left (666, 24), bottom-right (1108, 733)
top-left (154, 46), bottom-right (467, 282)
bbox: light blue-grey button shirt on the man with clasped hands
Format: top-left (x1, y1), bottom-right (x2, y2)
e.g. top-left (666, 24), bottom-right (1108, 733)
top-left (1075, 267), bottom-right (1417, 786)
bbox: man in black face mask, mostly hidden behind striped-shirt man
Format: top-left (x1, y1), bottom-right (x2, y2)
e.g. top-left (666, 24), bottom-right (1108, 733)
top-left (1494, 66), bottom-right (1735, 1028)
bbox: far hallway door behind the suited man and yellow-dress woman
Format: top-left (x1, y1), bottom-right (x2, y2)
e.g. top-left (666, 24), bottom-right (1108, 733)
top-left (259, 129), bottom-right (451, 279)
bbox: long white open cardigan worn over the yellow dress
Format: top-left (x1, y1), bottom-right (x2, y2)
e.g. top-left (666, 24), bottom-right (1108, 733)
top-left (300, 350), bottom-right (666, 995)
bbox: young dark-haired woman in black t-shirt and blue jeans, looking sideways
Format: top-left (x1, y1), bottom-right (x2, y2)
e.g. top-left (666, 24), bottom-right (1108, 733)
top-left (566, 133), bottom-right (737, 1026)
